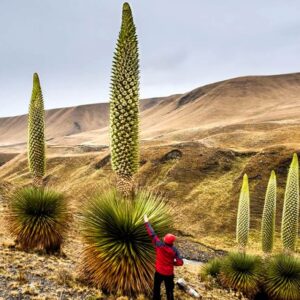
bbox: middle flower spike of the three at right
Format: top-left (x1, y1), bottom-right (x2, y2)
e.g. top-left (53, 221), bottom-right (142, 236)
top-left (261, 171), bottom-right (277, 253)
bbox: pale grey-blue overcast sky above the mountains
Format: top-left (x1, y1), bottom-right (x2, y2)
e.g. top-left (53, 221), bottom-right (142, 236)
top-left (0, 0), bottom-right (300, 116)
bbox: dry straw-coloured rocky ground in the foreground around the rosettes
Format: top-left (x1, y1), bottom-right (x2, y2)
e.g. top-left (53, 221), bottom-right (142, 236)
top-left (0, 192), bottom-right (241, 300)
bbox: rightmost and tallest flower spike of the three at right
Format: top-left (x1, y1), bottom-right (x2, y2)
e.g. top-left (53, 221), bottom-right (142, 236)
top-left (281, 153), bottom-right (299, 252)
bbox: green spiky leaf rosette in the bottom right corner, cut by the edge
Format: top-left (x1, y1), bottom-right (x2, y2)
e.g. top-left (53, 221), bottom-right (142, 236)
top-left (265, 255), bottom-right (300, 300)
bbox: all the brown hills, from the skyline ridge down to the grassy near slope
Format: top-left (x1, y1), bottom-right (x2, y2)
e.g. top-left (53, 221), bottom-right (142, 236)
top-left (0, 73), bottom-right (300, 248)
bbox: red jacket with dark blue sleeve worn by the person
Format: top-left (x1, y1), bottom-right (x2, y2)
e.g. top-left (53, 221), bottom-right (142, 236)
top-left (145, 222), bottom-right (183, 276)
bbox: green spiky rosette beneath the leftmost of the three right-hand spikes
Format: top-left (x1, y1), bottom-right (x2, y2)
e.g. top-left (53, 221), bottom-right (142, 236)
top-left (220, 253), bottom-right (262, 297)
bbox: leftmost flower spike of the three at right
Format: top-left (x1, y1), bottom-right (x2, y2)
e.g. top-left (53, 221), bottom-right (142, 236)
top-left (236, 174), bottom-right (250, 249)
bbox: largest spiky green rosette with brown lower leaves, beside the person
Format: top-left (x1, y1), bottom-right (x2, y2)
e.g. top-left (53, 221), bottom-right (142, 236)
top-left (80, 190), bottom-right (171, 295)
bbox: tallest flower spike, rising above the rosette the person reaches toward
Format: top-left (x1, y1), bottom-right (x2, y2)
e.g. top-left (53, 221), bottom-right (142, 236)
top-left (110, 3), bottom-right (139, 194)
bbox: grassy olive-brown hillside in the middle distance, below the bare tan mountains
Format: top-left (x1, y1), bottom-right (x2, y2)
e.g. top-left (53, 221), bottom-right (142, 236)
top-left (0, 142), bottom-right (300, 253)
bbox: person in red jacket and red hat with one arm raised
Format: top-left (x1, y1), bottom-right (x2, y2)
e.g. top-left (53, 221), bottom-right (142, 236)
top-left (144, 215), bottom-right (183, 300)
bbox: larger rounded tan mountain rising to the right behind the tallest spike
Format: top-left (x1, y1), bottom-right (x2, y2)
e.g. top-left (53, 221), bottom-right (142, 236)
top-left (53, 73), bottom-right (300, 150)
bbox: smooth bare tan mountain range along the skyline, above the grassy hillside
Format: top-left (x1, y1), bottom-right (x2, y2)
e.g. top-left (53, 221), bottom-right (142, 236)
top-left (0, 73), bottom-right (300, 152)
